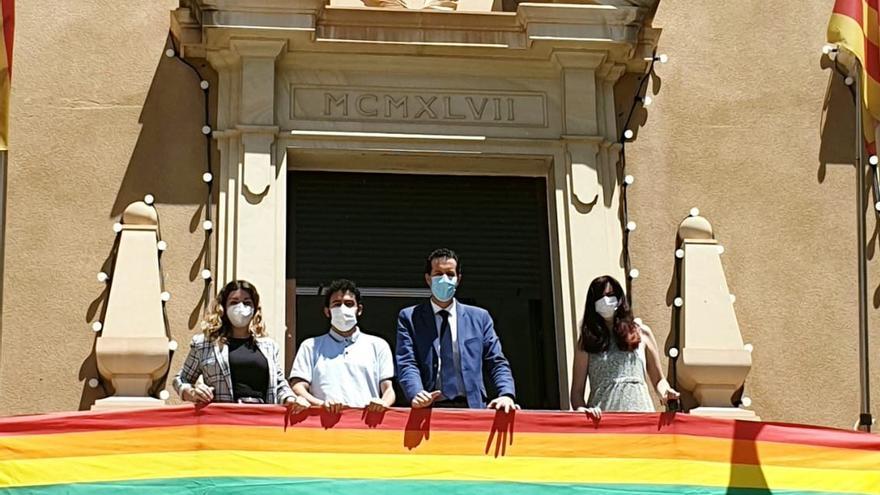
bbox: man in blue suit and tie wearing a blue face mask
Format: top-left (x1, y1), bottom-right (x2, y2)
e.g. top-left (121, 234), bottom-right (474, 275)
top-left (395, 249), bottom-right (519, 412)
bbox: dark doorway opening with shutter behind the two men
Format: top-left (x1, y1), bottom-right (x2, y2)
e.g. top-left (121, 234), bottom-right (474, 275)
top-left (287, 171), bottom-right (559, 409)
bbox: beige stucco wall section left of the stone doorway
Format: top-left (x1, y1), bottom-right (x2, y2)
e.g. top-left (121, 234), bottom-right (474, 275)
top-left (0, 0), bottom-right (205, 414)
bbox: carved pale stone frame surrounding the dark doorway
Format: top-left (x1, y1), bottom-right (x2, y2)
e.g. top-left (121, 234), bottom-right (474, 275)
top-left (180, 0), bottom-right (659, 409)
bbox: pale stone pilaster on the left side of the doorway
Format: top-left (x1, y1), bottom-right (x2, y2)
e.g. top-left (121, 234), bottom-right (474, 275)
top-left (208, 40), bottom-right (287, 347)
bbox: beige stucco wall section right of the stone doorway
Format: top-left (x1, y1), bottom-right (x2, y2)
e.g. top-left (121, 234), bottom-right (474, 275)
top-left (627, 0), bottom-right (880, 427)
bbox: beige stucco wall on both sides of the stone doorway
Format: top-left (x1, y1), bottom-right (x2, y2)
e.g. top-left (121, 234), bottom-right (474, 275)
top-left (0, 0), bottom-right (880, 427)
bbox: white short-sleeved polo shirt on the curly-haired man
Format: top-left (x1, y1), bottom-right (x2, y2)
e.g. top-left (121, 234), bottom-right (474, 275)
top-left (290, 329), bottom-right (394, 407)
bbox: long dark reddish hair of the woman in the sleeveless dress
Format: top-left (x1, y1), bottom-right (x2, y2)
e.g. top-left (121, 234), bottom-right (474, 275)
top-left (578, 275), bottom-right (642, 353)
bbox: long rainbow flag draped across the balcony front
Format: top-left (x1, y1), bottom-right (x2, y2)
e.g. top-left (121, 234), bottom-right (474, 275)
top-left (0, 404), bottom-right (880, 495)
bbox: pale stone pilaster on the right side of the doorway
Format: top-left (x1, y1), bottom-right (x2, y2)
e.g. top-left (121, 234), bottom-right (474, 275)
top-left (554, 52), bottom-right (625, 406)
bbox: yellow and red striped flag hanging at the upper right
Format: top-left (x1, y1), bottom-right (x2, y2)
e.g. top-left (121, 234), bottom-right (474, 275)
top-left (828, 0), bottom-right (880, 153)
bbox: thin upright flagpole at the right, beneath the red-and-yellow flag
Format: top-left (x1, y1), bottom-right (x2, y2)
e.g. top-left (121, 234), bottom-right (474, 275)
top-left (853, 63), bottom-right (873, 431)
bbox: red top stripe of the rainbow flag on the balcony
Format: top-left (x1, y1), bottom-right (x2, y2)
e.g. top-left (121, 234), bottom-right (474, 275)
top-left (0, 404), bottom-right (880, 452)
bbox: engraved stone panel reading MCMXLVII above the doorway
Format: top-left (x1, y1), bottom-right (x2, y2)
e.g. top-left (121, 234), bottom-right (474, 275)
top-left (291, 86), bottom-right (547, 127)
